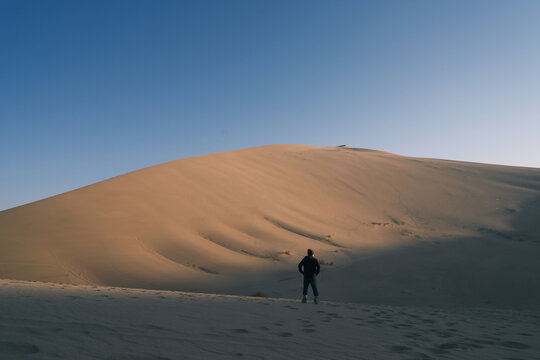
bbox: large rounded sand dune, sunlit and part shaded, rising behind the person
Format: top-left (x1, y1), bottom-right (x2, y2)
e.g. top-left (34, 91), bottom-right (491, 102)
top-left (0, 145), bottom-right (540, 306)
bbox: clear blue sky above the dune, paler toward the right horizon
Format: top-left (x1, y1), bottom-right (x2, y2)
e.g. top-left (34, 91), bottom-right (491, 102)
top-left (0, 0), bottom-right (540, 210)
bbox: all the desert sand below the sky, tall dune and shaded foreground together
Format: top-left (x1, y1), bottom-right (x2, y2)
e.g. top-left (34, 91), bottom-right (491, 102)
top-left (0, 145), bottom-right (540, 359)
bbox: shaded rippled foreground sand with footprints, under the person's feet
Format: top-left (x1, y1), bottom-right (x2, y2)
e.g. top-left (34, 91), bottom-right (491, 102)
top-left (0, 280), bottom-right (540, 360)
